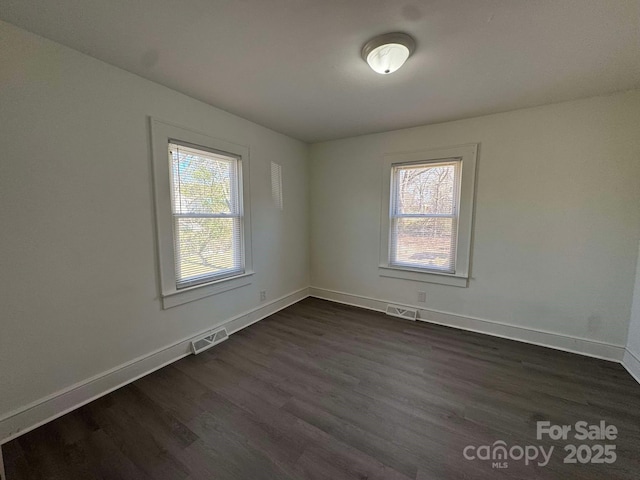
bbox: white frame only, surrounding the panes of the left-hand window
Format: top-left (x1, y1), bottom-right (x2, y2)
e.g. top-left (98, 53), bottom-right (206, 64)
top-left (150, 118), bottom-right (254, 309)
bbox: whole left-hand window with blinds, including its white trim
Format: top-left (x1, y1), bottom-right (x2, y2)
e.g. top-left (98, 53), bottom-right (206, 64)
top-left (151, 120), bottom-right (253, 308)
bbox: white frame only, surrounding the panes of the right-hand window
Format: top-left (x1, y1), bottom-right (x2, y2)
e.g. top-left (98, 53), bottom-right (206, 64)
top-left (378, 143), bottom-right (478, 287)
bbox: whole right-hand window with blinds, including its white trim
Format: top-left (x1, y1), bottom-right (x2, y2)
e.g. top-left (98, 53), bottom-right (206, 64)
top-left (380, 145), bottom-right (477, 286)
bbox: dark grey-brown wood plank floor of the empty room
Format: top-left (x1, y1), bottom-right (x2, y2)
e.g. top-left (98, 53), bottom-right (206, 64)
top-left (3, 298), bottom-right (640, 480)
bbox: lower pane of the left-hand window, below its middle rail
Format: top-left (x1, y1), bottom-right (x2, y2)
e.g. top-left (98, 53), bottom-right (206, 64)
top-left (175, 218), bottom-right (243, 286)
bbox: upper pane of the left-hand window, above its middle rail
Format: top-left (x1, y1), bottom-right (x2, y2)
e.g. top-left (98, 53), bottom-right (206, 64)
top-left (170, 145), bottom-right (238, 214)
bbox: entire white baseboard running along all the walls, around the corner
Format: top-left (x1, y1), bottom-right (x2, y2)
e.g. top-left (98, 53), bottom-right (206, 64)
top-left (0, 287), bottom-right (640, 448)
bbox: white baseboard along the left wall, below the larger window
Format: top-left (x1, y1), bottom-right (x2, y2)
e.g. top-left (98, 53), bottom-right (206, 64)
top-left (0, 288), bottom-right (309, 446)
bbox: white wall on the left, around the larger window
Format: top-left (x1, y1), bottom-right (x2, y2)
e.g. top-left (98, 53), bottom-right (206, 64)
top-left (0, 22), bottom-right (309, 440)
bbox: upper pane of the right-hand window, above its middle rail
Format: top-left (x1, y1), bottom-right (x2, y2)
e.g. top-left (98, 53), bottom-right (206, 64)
top-left (395, 163), bottom-right (456, 214)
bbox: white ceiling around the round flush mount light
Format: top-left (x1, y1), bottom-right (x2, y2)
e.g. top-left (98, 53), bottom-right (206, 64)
top-left (0, 0), bottom-right (640, 142)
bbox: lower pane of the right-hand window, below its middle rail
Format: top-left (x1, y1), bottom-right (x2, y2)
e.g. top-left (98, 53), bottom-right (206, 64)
top-left (391, 217), bottom-right (456, 273)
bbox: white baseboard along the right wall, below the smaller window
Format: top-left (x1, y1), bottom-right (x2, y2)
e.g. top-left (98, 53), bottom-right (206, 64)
top-left (309, 287), bottom-right (625, 362)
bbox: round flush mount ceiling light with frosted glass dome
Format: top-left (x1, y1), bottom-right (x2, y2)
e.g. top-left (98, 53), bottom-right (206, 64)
top-left (362, 32), bottom-right (416, 75)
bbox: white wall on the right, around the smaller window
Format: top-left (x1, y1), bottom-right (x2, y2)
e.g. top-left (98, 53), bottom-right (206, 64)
top-left (311, 91), bottom-right (640, 359)
